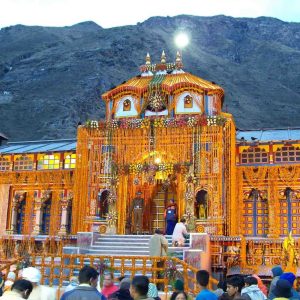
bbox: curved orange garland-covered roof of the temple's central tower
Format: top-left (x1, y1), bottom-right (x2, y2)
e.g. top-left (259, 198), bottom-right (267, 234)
top-left (102, 72), bottom-right (224, 101)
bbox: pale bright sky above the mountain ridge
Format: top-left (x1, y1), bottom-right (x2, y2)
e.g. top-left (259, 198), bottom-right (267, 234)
top-left (0, 0), bottom-right (300, 28)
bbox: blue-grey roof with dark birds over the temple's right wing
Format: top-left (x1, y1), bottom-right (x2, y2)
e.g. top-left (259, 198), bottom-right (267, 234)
top-left (236, 128), bottom-right (300, 143)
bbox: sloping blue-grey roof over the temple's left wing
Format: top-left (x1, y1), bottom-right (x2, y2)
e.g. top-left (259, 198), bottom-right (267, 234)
top-left (0, 139), bottom-right (76, 154)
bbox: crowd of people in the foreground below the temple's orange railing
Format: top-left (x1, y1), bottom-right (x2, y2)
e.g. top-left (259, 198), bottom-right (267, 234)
top-left (0, 264), bottom-right (300, 300)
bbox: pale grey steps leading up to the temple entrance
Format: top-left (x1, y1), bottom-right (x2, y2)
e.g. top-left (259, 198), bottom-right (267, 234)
top-left (84, 235), bottom-right (189, 259)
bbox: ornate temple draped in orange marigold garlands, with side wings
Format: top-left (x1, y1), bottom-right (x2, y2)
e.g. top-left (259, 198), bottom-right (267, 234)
top-left (0, 52), bottom-right (300, 272)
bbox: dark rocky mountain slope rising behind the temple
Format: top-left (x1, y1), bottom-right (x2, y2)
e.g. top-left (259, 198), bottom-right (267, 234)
top-left (0, 15), bottom-right (300, 140)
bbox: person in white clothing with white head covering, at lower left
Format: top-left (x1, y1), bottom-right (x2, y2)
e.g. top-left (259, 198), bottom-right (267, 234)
top-left (22, 267), bottom-right (56, 300)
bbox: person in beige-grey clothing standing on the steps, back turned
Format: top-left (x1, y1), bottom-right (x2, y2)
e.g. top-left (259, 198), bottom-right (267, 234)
top-left (149, 229), bottom-right (168, 290)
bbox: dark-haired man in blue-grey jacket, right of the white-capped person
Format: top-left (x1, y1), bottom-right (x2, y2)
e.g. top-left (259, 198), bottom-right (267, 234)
top-left (59, 266), bottom-right (106, 300)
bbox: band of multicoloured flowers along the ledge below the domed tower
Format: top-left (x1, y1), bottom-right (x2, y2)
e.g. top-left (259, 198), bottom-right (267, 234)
top-left (85, 115), bottom-right (226, 130)
